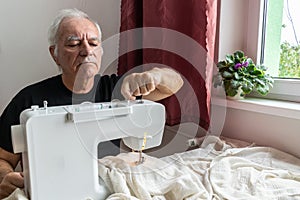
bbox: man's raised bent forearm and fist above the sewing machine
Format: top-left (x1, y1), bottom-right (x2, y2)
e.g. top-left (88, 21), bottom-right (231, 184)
top-left (121, 68), bottom-right (183, 101)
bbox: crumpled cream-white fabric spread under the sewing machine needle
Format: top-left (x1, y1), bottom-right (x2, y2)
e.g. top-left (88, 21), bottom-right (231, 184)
top-left (6, 136), bottom-right (300, 200)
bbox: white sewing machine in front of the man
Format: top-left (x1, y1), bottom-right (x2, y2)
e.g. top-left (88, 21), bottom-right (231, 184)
top-left (12, 100), bottom-right (165, 200)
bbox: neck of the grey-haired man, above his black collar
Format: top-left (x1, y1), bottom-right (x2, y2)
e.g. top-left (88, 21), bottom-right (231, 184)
top-left (62, 75), bottom-right (94, 94)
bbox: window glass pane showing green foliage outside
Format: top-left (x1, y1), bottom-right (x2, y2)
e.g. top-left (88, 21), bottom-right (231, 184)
top-left (261, 0), bottom-right (300, 79)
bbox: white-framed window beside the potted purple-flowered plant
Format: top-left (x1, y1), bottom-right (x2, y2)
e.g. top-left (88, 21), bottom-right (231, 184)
top-left (252, 0), bottom-right (300, 102)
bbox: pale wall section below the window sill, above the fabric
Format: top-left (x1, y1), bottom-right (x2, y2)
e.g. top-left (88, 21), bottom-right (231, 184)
top-left (222, 108), bottom-right (300, 158)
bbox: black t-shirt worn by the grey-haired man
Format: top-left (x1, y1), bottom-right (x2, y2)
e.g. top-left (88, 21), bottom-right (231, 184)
top-left (0, 75), bottom-right (121, 153)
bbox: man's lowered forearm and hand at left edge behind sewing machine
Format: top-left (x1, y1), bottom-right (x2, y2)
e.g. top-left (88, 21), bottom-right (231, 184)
top-left (0, 148), bottom-right (24, 199)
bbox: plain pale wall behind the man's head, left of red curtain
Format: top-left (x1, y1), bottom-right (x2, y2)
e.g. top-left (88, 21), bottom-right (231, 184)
top-left (0, 0), bottom-right (121, 113)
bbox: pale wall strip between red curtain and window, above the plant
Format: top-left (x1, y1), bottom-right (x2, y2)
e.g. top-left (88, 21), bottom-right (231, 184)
top-left (219, 0), bottom-right (261, 61)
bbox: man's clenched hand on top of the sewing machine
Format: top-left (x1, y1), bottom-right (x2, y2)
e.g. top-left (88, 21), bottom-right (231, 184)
top-left (121, 72), bottom-right (156, 100)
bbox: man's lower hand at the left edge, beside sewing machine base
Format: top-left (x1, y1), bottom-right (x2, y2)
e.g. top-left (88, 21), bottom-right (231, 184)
top-left (0, 172), bottom-right (24, 199)
